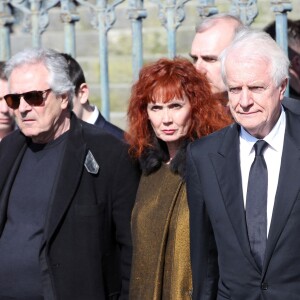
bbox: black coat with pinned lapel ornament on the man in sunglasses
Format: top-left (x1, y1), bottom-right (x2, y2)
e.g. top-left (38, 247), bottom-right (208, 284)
top-left (0, 114), bottom-right (139, 300)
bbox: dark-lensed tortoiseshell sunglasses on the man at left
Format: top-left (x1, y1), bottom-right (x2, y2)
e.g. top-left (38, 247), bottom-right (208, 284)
top-left (4, 89), bottom-right (51, 109)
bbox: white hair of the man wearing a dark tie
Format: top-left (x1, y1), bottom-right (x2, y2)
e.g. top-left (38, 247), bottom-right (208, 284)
top-left (219, 28), bottom-right (290, 87)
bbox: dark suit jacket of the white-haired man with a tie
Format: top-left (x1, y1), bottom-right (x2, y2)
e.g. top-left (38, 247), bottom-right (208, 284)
top-left (187, 110), bottom-right (300, 300)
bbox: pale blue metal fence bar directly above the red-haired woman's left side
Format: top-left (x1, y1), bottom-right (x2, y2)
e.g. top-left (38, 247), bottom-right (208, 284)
top-left (127, 0), bottom-right (147, 81)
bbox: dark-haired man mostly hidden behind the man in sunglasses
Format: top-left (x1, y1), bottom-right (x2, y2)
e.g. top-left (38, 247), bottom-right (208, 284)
top-left (62, 53), bottom-right (124, 140)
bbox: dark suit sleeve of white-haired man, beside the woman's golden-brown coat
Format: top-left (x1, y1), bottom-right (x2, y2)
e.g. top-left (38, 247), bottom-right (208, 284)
top-left (187, 145), bottom-right (219, 300)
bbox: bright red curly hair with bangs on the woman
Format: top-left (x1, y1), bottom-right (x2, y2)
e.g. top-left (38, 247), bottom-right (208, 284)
top-left (125, 57), bottom-right (232, 158)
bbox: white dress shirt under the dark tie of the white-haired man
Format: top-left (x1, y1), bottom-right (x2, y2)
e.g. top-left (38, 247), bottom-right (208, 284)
top-left (240, 108), bottom-right (286, 233)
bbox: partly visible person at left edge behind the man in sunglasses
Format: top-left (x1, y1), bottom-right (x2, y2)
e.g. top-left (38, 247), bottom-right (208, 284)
top-left (0, 61), bottom-right (15, 141)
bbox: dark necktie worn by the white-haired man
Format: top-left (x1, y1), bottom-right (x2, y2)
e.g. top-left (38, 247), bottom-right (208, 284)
top-left (246, 140), bottom-right (268, 269)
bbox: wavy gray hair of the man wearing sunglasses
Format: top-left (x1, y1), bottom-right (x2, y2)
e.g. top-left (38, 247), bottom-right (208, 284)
top-left (5, 48), bottom-right (74, 110)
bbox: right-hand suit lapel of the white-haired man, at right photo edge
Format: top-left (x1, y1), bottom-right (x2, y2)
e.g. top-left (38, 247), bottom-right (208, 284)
top-left (264, 111), bottom-right (300, 271)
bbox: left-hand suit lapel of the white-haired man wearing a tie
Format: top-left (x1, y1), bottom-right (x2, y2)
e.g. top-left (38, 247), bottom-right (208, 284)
top-left (211, 124), bottom-right (258, 268)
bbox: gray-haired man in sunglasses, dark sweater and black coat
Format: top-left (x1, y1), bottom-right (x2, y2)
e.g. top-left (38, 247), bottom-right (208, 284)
top-left (0, 49), bottom-right (139, 300)
